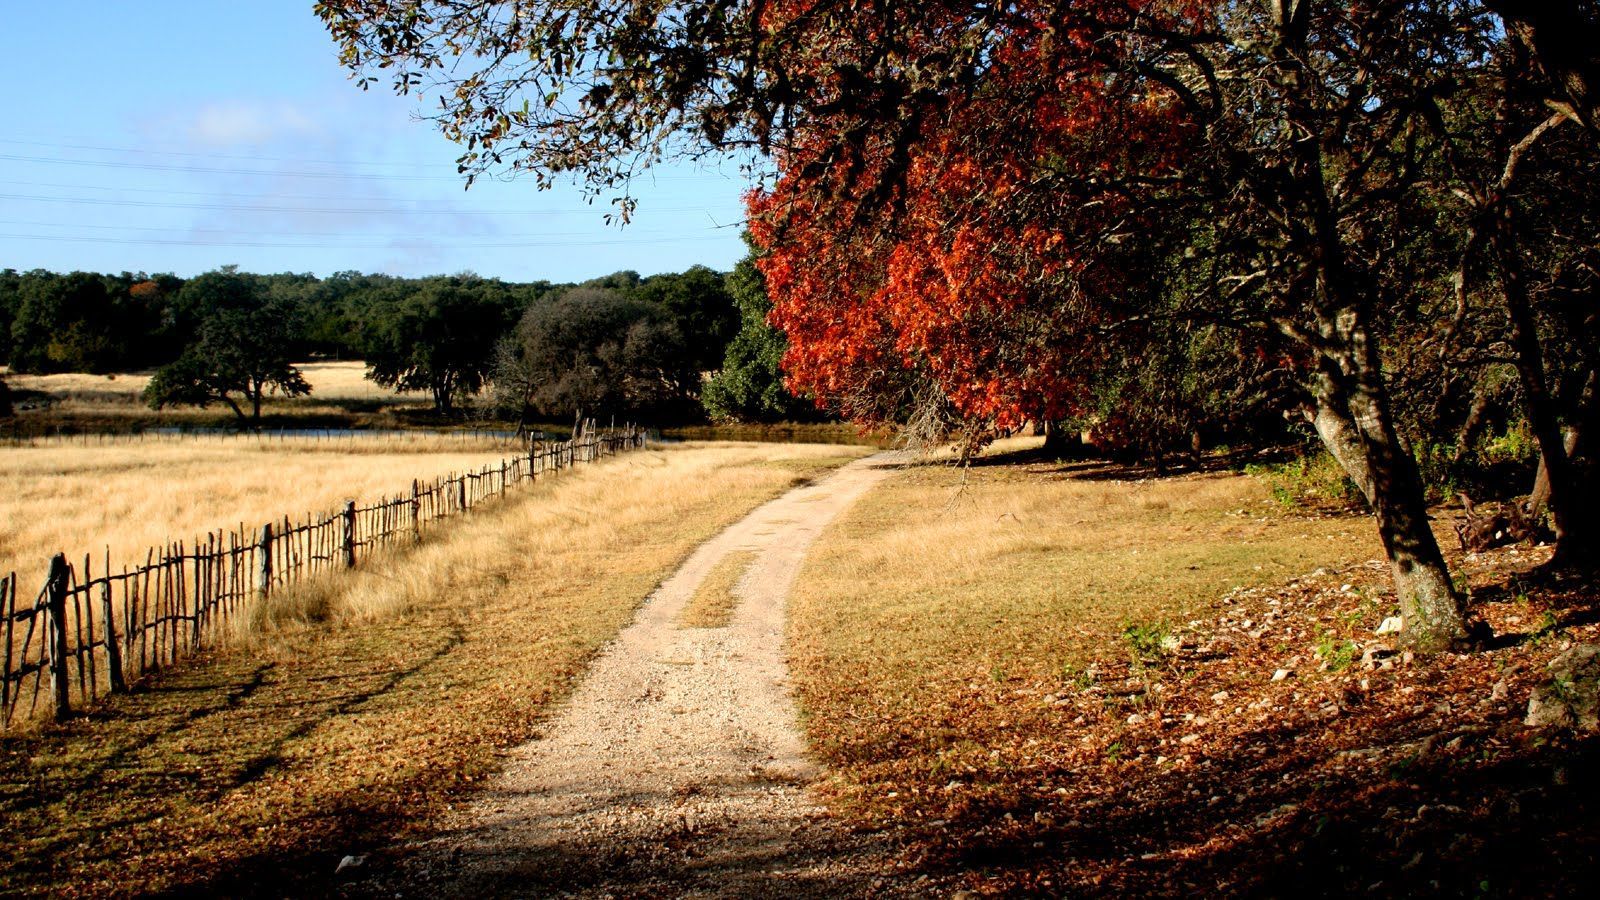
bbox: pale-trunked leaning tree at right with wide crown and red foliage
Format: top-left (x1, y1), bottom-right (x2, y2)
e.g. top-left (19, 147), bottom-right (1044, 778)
top-left (318, 0), bottom-right (1589, 649)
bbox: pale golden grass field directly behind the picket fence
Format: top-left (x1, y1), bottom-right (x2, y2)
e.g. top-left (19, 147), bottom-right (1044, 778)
top-left (0, 436), bottom-right (509, 591)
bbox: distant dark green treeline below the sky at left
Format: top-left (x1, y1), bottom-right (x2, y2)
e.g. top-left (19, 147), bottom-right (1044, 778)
top-left (0, 256), bottom-right (806, 421)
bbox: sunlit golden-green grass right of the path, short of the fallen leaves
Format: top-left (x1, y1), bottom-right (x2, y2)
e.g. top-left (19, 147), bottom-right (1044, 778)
top-left (790, 438), bottom-right (1379, 796)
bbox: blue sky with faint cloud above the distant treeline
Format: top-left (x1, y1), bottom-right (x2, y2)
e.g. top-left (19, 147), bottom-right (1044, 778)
top-left (0, 0), bottom-right (746, 280)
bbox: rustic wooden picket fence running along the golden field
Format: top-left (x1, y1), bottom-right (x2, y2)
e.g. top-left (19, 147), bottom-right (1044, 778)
top-left (0, 421), bottom-right (645, 729)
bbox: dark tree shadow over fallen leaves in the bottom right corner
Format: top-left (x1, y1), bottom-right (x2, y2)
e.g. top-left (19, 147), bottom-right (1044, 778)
top-left (889, 679), bottom-right (1600, 897)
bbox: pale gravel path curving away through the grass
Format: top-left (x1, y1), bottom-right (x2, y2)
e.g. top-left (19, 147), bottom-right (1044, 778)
top-left (405, 453), bottom-right (915, 897)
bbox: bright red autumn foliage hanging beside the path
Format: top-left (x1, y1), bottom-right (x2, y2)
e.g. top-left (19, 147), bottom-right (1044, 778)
top-left (749, 10), bottom-right (1186, 439)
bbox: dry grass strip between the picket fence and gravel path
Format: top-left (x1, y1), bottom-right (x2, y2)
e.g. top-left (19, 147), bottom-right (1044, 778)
top-left (0, 445), bottom-right (870, 895)
